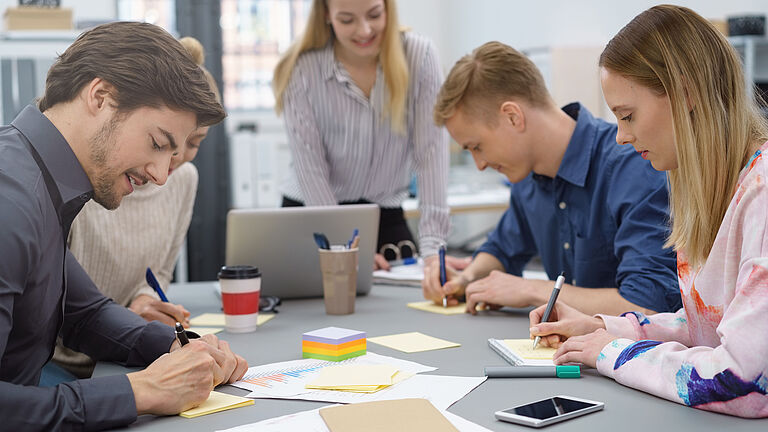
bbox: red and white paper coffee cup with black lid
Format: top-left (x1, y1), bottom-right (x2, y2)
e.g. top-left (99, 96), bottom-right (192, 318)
top-left (219, 266), bottom-right (261, 333)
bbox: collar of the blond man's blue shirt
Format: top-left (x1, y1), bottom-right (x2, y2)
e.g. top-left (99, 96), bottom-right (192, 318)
top-left (557, 102), bottom-right (597, 187)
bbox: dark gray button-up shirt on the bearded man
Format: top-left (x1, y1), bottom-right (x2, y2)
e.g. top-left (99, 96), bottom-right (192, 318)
top-left (0, 106), bottom-right (174, 431)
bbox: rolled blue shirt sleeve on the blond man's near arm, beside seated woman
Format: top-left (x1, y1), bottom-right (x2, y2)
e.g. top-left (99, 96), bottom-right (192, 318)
top-left (607, 152), bottom-right (682, 312)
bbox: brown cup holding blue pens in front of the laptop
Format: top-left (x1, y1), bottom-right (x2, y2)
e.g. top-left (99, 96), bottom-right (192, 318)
top-left (318, 248), bottom-right (358, 315)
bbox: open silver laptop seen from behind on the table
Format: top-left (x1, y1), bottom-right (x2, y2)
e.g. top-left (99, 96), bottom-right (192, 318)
top-left (225, 204), bottom-right (379, 299)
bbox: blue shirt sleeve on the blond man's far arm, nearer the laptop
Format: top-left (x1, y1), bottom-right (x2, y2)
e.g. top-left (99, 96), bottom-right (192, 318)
top-left (475, 190), bottom-right (538, 276)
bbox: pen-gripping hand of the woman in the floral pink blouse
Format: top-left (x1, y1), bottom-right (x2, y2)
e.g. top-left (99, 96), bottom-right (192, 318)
top-left (528, 301), bottom-right (605, 348)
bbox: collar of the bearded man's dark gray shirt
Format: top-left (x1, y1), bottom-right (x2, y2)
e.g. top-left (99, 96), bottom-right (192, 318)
top-left (11, 105), bottom-right (93, 205)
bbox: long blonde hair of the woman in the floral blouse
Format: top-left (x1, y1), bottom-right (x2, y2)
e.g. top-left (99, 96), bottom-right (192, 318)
top-left (600, 5), bottom-right (768, 266)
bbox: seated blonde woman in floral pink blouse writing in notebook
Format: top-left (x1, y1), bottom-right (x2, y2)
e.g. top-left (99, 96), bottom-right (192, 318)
top-left (531, 5), bottom-right (768, 417)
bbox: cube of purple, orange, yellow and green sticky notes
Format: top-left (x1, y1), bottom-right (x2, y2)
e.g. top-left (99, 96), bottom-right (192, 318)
top-left (301, 327), bottom-right (366, 361)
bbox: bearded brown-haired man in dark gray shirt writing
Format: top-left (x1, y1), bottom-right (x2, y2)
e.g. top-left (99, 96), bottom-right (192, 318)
top-left (0, 23), bottom-right (247, 430)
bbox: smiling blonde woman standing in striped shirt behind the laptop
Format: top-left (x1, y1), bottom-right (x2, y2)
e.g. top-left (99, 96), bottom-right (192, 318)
top-left (274, 0), bottom-right (449, 268)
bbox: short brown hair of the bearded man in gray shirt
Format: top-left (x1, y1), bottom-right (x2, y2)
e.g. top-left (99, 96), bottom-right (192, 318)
top-left (38, 22), bottom-right (226, 126)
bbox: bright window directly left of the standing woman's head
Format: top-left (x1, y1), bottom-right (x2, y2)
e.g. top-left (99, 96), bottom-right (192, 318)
top-left (221, 0), bottom-right (311, 111)
